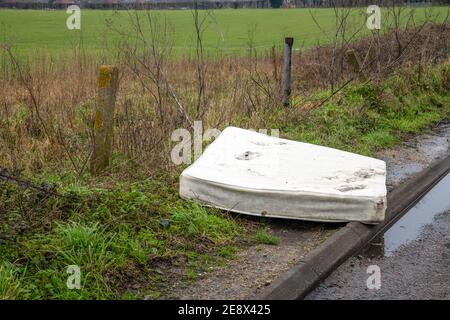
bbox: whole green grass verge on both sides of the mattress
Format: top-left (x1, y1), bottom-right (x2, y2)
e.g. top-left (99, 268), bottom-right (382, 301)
top-left (0, 62), bottom-right (450, 299)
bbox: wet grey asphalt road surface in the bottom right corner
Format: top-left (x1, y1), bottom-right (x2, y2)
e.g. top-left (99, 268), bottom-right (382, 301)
top-left (306, 210), bottom-right (450, 300)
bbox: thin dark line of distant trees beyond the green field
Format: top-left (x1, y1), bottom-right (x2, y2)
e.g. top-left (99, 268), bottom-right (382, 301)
top-left (0, 0), bottom-right (450, 9)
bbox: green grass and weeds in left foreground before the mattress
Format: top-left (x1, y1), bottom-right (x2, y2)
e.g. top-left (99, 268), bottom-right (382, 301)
top-left (0, 174), bottom-right (246, 299)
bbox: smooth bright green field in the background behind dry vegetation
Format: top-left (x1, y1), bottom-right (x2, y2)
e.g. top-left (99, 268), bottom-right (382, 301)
top-left (0, 7), bottom-right (448, 55)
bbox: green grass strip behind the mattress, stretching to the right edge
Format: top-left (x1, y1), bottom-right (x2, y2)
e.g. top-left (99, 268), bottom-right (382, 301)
top-left (281, 63), bottom-right (450, 156)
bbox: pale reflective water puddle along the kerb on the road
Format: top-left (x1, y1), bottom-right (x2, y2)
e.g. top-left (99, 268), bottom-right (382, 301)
top-left (363, 174), bottom-right (450, 257)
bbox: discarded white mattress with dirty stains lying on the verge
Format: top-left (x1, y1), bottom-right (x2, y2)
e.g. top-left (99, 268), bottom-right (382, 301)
top-left (180, 127), bottom-right (386, 223)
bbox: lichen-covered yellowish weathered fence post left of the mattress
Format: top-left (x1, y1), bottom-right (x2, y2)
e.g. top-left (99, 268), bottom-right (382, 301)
top-left (90, 66), bottom-right (119, 175)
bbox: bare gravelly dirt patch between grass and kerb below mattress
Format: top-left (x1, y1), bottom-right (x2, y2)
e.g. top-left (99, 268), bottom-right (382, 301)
top-left (174, 220), bottom-right (337, 300)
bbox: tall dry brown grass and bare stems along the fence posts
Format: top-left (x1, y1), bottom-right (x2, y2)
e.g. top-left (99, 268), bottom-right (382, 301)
top-left (0, 11), bottom-right (450, 180)
